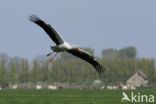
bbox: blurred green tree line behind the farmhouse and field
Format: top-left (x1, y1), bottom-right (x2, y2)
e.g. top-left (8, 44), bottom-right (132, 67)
top-left (0, 47), bottom-right (156, 85)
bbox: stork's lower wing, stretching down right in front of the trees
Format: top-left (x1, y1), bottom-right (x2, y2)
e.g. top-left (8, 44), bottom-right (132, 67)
top-left (67, 48), bottom-right (105, 75)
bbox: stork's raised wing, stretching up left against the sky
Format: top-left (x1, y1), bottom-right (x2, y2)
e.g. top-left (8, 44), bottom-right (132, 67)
top-left (29, 15), bottom-right (64, 45)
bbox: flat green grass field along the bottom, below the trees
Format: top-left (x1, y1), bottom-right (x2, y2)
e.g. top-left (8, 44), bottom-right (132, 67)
top-left (0, 88), bottom-right (156, 104)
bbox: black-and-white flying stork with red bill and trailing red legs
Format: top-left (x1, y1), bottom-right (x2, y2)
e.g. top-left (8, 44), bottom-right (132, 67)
top-left (29, 15), bottom-right (104, 75)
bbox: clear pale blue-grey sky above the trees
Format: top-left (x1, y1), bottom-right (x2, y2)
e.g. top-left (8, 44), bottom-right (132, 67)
top-left (0, 0), bottom-right (156, 59)
